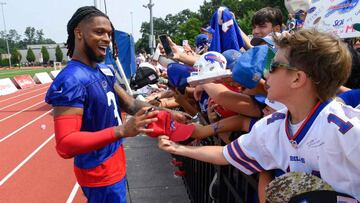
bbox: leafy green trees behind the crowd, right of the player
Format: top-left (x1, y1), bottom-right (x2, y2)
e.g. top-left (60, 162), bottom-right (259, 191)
top-left (135, 0), bottom-right (287, 53)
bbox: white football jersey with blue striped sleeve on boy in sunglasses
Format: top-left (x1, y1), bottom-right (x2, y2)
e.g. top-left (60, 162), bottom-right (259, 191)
top-left (223, 101), bottom-right (360, 200)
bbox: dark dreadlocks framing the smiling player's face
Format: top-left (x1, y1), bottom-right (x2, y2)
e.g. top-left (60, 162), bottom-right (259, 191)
top-left (66, 6), bottom-right (118, 58)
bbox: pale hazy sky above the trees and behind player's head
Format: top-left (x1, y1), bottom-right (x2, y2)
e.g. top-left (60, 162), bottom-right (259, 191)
top-left (0, 0), bottom-right (204, 43)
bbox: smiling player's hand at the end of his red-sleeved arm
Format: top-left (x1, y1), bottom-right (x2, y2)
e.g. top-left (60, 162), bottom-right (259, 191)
top-left (120, 107), bottom-right (159, 137)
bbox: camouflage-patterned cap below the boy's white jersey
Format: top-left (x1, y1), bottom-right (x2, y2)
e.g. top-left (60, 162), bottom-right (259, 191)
top-left (265, 172), bottom-right (333, 203)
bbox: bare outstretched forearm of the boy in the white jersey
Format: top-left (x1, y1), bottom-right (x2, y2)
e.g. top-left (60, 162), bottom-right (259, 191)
top-left (174, 145), bottom-right (229, 165)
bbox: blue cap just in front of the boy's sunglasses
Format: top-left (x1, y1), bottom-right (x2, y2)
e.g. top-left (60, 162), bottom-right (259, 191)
top-left (232, 45), bottom-right (272, 89)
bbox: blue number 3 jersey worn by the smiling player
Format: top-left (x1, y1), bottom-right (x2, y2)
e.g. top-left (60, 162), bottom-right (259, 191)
top-left (45, 60), bottom-right (122, 169)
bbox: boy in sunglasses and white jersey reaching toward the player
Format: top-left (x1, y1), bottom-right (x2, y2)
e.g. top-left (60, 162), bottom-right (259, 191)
top-left (158, 30), bottom-right (360, 200)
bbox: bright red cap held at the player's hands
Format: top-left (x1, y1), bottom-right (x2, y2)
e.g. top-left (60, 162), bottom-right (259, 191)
top-left (147, 110), bottom-right (195, 142)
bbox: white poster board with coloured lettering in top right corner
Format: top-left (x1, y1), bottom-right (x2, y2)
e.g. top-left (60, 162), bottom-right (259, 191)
top-left (304, 0), bottom-right (360, 38)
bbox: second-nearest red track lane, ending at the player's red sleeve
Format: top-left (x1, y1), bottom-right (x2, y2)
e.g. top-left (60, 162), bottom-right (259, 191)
top-left (0, 114), bottom-right (54, 178)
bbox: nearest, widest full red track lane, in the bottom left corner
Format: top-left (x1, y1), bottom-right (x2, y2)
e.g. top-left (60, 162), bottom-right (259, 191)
top-left (0, 135), bottom-right (84, 203)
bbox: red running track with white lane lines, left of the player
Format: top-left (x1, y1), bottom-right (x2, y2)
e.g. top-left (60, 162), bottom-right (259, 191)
top-left (0, 84), bottom-right (86, 203)
